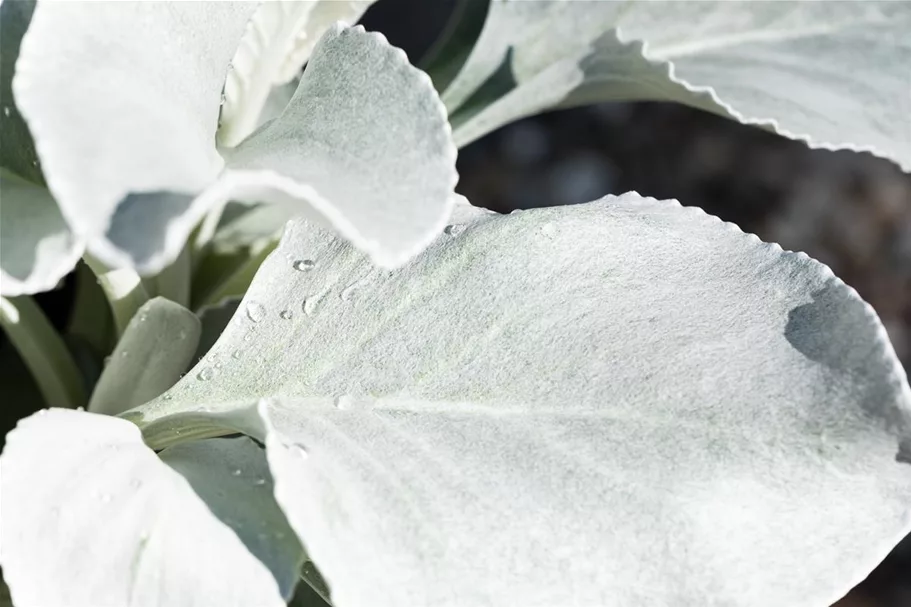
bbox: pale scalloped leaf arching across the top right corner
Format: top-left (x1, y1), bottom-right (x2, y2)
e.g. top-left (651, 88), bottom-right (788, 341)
top-left (443, 0), bottom-right (911, 170)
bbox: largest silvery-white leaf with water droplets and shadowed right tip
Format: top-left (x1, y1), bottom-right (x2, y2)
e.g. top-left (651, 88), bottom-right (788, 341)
top-left (141, 195), bottom-right (911, 607)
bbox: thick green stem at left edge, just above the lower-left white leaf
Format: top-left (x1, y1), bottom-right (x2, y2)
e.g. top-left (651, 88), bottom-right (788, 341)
top-left (0, 296), bottom-right (86, 408)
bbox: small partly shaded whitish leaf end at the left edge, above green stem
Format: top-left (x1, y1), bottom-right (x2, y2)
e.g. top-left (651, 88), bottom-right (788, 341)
top-left (0, 170), bottom-right (83, 297)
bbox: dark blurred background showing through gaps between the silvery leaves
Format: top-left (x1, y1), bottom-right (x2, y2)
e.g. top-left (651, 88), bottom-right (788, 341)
top-left (0, 0), bottom-right (911, 607)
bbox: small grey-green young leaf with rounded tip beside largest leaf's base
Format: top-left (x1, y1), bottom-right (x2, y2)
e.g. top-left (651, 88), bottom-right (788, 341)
top-left (89, 297), bottom-right (201, 415)
